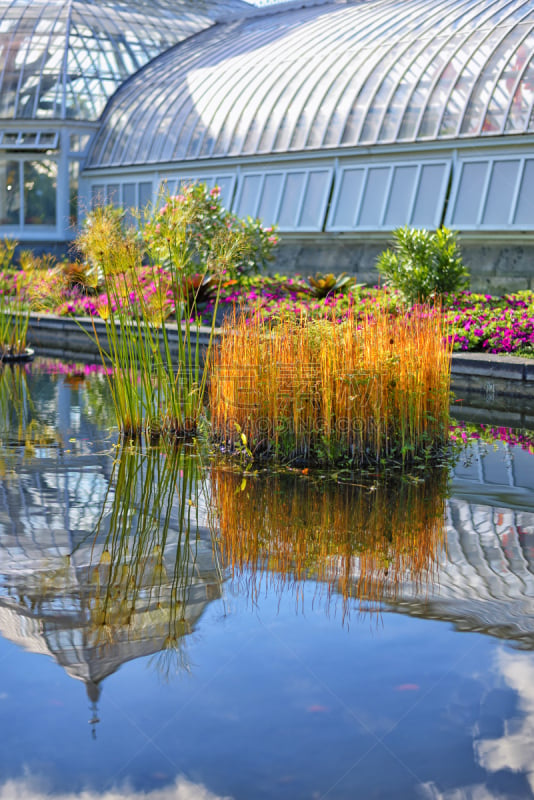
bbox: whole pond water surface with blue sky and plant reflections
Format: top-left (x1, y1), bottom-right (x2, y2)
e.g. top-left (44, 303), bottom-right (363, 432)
top-left (0, 360), bottom-right (534, 800)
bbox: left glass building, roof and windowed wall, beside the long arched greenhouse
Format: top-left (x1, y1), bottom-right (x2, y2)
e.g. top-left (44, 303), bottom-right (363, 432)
top-left (0, 0), bottom-right (248, 242)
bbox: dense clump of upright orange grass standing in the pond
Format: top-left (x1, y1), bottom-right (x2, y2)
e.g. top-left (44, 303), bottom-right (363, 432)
top-left (210, 306), bottom-right (451, 464)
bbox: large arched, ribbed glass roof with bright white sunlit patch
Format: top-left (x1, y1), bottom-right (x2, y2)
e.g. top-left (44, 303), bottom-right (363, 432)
top-left (89, 0), bottom-right (534, 167)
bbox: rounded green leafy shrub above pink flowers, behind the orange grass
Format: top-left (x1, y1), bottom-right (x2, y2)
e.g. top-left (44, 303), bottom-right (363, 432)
top-left (377, 227), bottom-right (469, 303)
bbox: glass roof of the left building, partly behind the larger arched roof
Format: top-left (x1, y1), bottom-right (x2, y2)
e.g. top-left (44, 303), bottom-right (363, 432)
top-left (0, 0), bottom-right (249, 120)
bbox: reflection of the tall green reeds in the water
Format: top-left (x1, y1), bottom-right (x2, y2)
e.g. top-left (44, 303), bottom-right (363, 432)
top-left (90, 446), bottom-right (216, 664)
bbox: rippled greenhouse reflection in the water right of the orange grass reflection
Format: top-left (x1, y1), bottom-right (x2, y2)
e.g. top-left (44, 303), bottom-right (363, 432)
top-left (382, 442), bottom-right (534, 650)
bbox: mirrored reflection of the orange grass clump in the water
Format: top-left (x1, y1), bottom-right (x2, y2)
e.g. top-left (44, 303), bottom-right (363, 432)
top-left (211, 466), bottom-right (448, 611)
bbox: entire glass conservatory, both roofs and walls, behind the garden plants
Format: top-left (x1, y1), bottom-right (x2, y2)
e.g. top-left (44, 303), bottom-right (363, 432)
top-left (0, 0), bottom-right (534, 276)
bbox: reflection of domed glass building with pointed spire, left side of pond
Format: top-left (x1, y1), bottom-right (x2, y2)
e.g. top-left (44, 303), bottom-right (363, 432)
top-left (0, 364), bottom-right (221, 732)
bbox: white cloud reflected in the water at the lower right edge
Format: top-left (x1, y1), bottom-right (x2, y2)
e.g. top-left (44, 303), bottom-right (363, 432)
top-left (474, 650), bottom-right (534, 793)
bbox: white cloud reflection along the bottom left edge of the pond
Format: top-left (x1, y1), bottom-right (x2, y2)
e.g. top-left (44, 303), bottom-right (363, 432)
top-left (0, 776), bottom-right (231, 800)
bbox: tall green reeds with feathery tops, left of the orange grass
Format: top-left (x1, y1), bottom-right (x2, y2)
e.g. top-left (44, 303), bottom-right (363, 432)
top-left (78, 198), bottom-right (234, 436)
